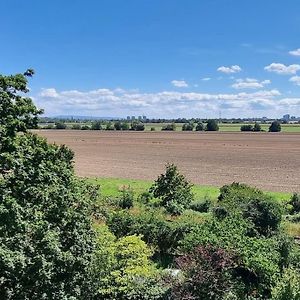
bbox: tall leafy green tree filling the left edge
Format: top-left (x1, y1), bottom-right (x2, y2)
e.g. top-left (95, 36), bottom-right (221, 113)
top-left (0, 70), bottom-right (95, 299)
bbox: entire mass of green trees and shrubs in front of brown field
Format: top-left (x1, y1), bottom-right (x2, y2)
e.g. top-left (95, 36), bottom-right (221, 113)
top-left (0, 70), bottom-right (300, 300)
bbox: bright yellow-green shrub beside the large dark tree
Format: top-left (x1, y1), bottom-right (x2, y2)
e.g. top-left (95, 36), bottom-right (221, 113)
top-left (92, 226), bottom-right (164, 300)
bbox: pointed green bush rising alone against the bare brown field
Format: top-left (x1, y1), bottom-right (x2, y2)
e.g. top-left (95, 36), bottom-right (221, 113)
top-left (150, 164), bottom-right (194, 215)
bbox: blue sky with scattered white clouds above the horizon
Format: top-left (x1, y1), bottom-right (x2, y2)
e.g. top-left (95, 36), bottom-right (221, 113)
top-left (0, 0), bottom-right (300, 118)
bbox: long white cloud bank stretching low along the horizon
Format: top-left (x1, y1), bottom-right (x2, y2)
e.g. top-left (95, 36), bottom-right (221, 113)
top-left (35, 88), bottom-right (292, 117)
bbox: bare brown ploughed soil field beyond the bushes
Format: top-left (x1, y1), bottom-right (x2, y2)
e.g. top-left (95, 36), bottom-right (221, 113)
top-left (37, 130), bottom-right (300, 192)
